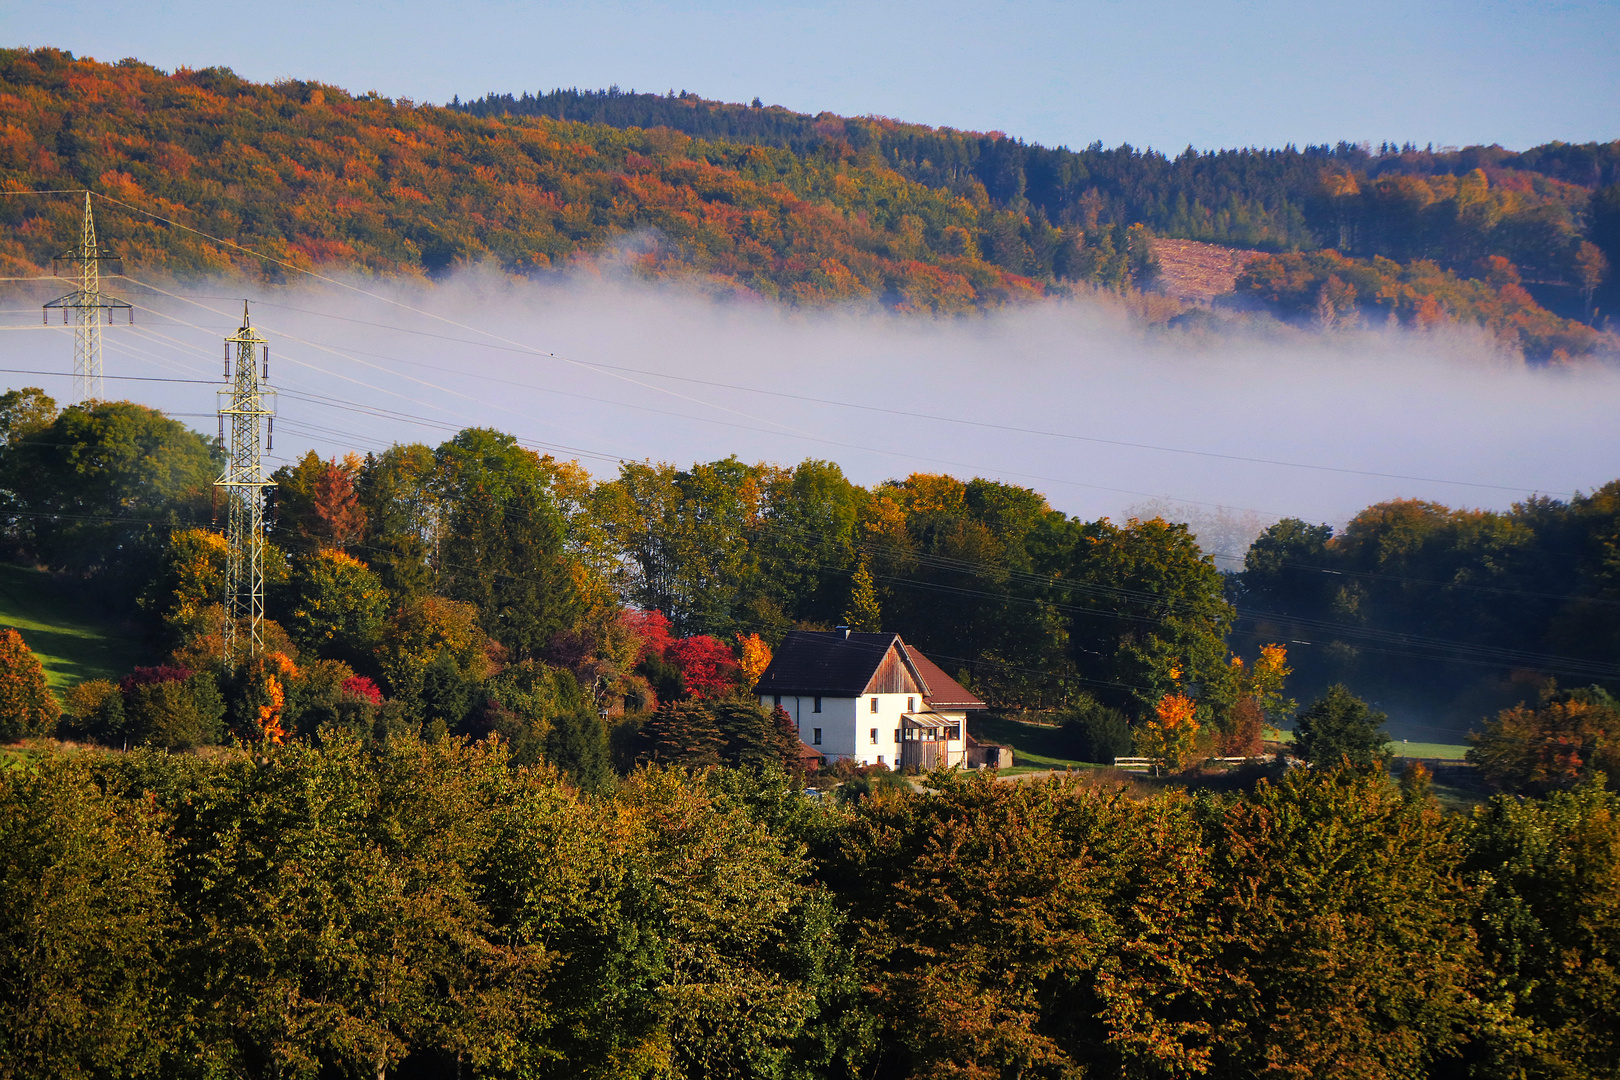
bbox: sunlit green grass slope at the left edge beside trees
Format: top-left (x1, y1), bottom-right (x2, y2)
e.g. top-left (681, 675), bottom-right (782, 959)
top-left (0, 563), bottom-right (146, 693)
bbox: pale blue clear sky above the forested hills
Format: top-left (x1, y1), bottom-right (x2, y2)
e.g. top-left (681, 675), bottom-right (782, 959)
top-left (12, 0), bottom-right (1620, 152)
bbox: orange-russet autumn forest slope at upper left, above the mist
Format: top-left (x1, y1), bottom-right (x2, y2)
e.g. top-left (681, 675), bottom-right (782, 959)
top-left (0, 49), bottom-right (1042, 311)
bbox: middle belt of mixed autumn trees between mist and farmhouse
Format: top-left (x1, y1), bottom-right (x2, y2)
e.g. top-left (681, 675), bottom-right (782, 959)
top-left (0, 390), bottom-right (1620, 751)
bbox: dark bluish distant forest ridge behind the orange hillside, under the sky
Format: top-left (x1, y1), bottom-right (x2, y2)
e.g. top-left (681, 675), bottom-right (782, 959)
top-left (457, 89), bottom-right (1620, 310)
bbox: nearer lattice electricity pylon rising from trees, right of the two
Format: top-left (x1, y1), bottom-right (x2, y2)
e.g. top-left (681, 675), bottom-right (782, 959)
top-left (214, 301), bottom-right (275, 661)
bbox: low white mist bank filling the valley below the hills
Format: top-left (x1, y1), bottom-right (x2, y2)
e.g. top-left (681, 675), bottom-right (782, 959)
top-left (5, 262), bottom-right (1620, 550)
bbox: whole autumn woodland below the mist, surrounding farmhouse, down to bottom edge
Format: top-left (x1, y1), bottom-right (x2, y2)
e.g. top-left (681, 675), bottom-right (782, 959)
top-left (0, 390), bottom-right (1620, 1080)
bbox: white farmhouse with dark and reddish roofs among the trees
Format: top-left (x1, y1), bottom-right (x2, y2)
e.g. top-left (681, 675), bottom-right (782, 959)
top-left (755, 628), bottom-right (985, 769)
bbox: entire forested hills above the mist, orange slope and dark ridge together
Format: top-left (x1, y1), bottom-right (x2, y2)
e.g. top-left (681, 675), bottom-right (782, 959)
top-left (0, 49), bottom-right (1620, 359)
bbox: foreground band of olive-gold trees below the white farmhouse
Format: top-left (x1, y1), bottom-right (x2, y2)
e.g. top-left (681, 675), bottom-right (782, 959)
top-left (0, 737), bottom-right (1620, 1080)
